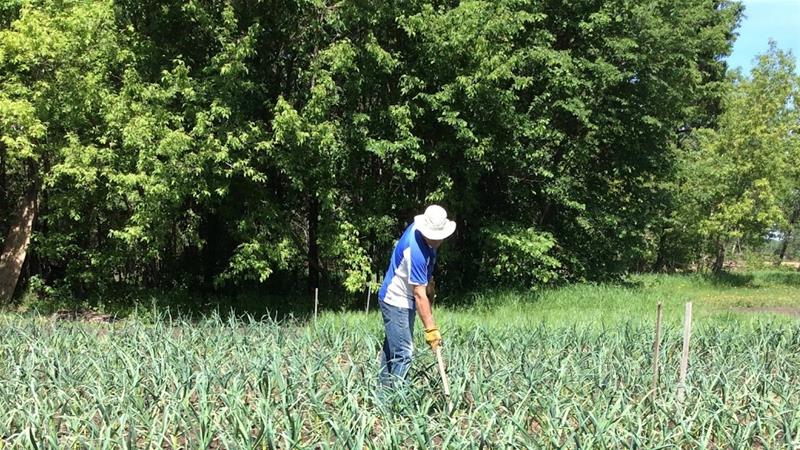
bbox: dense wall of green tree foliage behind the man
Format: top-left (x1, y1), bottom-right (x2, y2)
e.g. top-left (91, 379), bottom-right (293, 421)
top-left (0, 0), bottom-right (748, 302)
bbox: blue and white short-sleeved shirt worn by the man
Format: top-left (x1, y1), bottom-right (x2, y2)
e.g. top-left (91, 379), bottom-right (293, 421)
top-left (378, 222), bottom-right (436, 309)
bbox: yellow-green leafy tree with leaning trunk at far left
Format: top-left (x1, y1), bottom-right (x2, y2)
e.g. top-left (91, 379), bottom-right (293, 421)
top-left (0, 1), bottom-right (122, 302)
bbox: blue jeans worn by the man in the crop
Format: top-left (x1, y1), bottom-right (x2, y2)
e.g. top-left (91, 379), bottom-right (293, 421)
top-left (378, 300), bottom-right (414, 387)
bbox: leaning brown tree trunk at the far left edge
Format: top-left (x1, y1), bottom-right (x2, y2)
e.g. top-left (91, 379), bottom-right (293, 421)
top-left (0, 188), bottom-right (37, 304)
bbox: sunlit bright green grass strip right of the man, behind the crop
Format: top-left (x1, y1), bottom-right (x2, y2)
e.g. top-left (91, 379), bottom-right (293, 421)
top-left (336, 270), bottom-right (800, 328)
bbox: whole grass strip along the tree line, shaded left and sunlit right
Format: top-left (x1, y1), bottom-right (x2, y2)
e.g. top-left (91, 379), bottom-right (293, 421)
top-left (18, 269), bottom-right (800, 327)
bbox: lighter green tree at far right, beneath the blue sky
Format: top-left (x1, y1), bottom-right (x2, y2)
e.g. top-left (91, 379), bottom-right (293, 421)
top-left (678, 42), bottom-right (800, 272)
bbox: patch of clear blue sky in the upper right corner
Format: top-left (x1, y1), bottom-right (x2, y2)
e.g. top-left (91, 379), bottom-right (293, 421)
top-left (728, 0), bottom-right (800, 73)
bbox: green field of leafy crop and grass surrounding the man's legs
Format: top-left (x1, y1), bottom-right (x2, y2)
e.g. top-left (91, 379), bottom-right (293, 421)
top-left (0, 271), bottom-right (800, 449)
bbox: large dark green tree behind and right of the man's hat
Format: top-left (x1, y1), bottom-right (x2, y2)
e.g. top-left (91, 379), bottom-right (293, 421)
top-left (390, 1), bottom-right (741, 283)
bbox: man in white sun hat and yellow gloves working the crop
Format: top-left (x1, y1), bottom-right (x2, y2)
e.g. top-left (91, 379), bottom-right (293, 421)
top-left (378, 205), bottom-right (456, 386)
